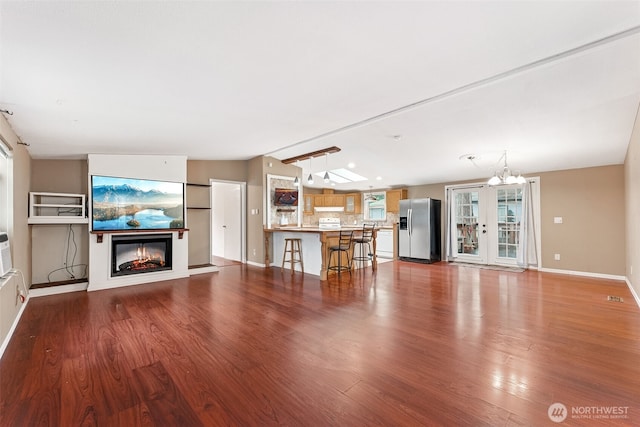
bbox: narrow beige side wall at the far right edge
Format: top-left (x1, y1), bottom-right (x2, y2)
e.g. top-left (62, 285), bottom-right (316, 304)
top-left (624, 105), bottom-right (640, 303)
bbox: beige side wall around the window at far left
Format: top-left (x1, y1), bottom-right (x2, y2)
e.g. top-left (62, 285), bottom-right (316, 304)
top-left (0, 114), bottom-right (31, 352)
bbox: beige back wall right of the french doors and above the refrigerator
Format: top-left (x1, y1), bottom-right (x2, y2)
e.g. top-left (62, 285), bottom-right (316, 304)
top-left (408, 165), bottom-right (625, 276)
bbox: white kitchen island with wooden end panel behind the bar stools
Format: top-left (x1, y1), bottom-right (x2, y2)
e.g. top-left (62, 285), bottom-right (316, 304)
top-left (264, 226), bottom-right (378, 280)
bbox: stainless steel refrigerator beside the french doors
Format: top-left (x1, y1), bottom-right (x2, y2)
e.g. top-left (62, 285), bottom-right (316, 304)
top-left (398, 198), bottom-right (442, 263)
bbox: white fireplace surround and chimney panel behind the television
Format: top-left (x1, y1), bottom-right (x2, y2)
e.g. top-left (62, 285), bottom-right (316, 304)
top-left (87, 154), bottom-right (189, 291)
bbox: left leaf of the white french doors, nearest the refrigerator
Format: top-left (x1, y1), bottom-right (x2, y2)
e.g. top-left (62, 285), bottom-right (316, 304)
top-left (449, 186), bottom-right (488, 264)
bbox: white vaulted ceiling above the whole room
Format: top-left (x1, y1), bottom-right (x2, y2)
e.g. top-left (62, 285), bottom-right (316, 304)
top-left (0, 0), bottom-right (640, 190)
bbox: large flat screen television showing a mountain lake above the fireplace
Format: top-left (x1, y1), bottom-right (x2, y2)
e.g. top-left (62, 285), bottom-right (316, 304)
top-left (91, 175), bottom-right (185, 231)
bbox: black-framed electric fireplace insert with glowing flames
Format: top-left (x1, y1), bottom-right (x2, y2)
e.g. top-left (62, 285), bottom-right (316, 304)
top-left (111, 233), bottom-right (172, 277)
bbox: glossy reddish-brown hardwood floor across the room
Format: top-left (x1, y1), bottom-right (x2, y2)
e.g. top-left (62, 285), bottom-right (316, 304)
top-left (0, 262), bottom-right (640, 426)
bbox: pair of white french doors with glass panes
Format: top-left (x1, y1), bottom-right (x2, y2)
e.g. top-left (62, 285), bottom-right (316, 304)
top-left (449, 185), bottom-right (523, 265)
